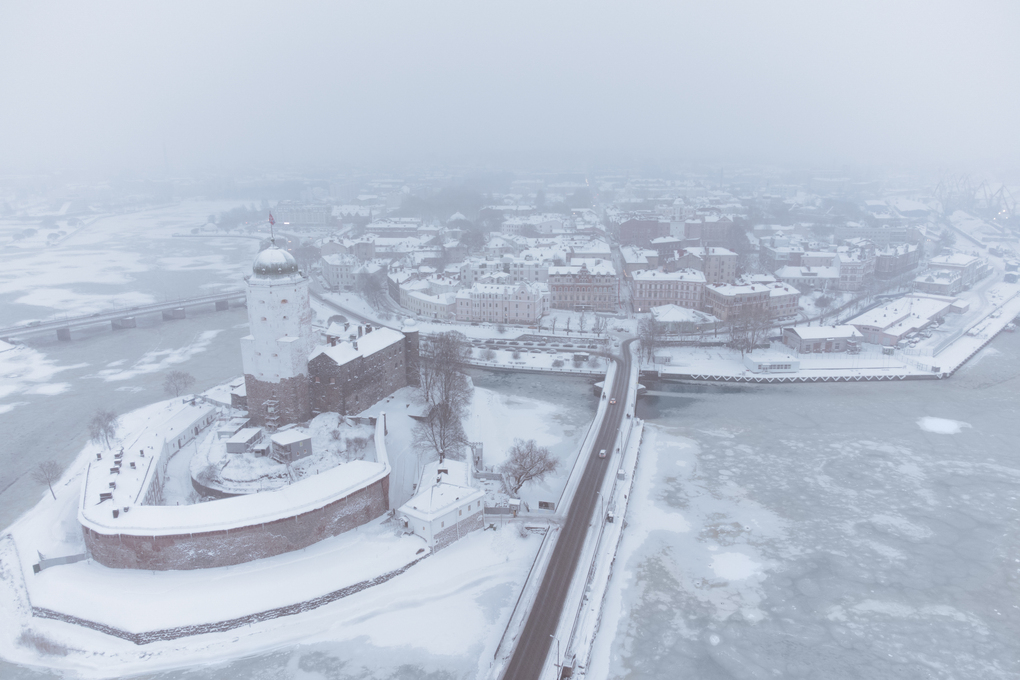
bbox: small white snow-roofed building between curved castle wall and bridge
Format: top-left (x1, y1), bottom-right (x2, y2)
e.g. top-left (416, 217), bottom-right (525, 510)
top-left (397, 459), bottom-right (486, 551)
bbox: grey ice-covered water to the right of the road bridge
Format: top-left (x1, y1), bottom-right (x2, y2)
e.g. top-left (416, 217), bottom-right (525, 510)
top-left (593, 334), bottom-right (1020, 679)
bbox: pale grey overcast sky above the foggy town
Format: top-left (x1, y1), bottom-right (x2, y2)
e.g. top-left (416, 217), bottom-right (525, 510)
top-left (0, 0), bottom-right (1020, 173)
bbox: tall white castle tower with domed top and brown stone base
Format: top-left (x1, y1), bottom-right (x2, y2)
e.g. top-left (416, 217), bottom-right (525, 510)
top-left (241, 244), bottom-right (314, 429)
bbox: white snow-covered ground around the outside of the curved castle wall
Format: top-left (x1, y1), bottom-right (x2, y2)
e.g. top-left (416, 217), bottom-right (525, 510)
top-left (0, 390), bottom-right (557, 677)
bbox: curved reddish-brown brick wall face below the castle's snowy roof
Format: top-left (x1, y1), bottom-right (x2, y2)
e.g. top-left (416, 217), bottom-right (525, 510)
top-left (83, 475), bottom-right (390, 571)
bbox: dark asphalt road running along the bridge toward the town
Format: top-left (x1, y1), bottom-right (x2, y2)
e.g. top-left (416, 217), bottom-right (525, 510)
top-left (503, 338), bottom-right (635, 680)
